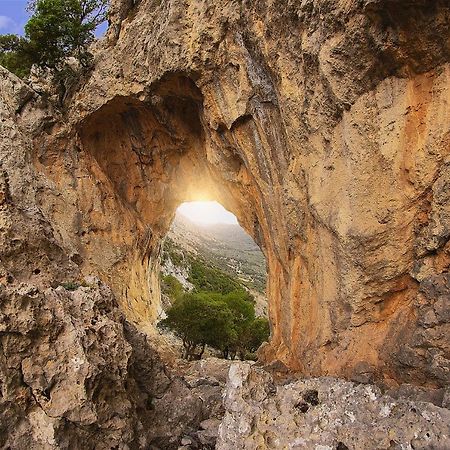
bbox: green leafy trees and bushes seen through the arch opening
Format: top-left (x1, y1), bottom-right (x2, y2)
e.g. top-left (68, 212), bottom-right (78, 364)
top-left (159, 239), bottom-right (270, 359)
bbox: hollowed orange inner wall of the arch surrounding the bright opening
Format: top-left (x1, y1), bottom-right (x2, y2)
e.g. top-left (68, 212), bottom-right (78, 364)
top-left (74, 74), bottom-right (284, 366)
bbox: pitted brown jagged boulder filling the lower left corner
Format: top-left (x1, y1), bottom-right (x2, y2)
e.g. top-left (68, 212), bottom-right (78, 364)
top-left (0, 284), bottom-right (135, 449)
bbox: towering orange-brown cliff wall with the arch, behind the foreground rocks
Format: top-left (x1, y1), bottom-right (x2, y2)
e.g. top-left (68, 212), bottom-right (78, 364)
top-left (0, 0), bottom-right (450, 444)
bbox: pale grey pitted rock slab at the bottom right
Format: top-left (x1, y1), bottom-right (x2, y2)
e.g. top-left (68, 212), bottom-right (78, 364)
top-left (216, 363), bottom-right (450, 450)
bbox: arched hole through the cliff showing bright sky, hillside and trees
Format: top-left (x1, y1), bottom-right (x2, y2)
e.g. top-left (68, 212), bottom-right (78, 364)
top-left (157, 200), bottom-right (270, 359)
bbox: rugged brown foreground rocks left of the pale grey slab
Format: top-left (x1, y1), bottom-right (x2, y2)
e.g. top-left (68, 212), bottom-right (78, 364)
top-left (0, 280), bottom-right (229, 450)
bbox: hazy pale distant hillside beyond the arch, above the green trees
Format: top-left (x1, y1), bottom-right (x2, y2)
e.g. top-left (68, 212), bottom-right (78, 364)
top-left (168, 214), bottom-right (266, 293)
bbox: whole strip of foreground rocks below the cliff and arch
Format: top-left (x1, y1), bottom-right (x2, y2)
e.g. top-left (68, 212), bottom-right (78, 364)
top-left (0, 279), bottom-right (450, 450)
